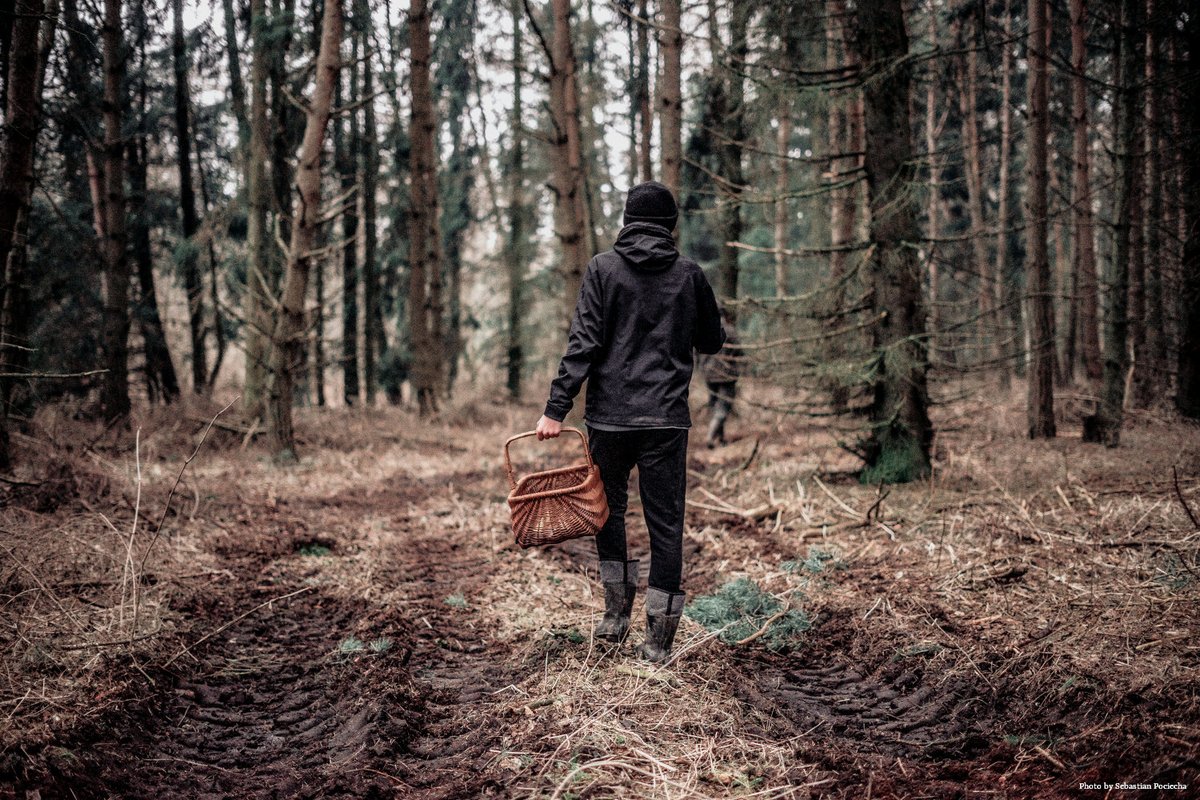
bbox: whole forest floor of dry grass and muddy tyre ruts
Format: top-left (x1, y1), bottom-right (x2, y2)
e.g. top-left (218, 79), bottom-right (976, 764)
top-left (0, 390), bottom-right (1200, 800)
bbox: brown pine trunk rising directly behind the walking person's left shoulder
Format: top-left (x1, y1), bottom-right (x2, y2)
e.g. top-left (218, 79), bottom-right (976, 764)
top-left (550, 0), bottom-right (590, 329)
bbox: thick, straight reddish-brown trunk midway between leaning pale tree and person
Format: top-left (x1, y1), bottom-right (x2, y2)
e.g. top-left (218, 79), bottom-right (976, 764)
top-left (408, 0), bottom-right (445, 416)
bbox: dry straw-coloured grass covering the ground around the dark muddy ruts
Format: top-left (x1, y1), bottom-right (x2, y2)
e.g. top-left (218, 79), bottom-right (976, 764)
top-left (0, 389), bottom-right (1200, 800)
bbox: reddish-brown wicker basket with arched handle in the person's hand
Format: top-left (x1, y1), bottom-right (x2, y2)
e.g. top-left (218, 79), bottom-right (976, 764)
top-left (504, 428), bottom-right (608, 547)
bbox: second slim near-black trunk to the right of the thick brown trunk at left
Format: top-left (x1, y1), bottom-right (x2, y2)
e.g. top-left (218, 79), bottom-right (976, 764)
top-left (172, 0), bottom-right (209, 395)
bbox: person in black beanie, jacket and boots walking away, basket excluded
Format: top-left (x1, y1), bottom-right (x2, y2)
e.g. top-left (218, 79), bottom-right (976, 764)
top-left (538, 181), bottom-right (725, 662)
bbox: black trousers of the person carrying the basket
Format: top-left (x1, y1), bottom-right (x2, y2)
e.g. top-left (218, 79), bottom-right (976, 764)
top-left (588, 426), bottom-right (688, 593)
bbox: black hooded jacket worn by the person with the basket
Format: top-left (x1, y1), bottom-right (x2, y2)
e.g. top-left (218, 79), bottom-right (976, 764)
top-left (546, 222), bottom-right (725, 428)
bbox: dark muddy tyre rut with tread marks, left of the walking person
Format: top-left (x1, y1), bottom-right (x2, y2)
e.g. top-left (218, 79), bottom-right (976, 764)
top-left (43, 587), bottom-right (416, 799)
